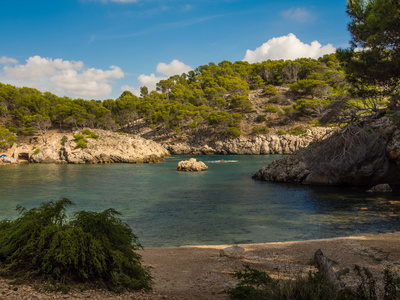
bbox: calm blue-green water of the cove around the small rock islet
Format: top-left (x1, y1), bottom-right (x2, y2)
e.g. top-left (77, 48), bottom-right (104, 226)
top-left (0, 155), bottom-right (400, 247)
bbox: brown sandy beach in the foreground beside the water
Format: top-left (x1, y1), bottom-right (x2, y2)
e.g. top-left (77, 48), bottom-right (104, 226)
top-left (0, 232), bottom-right (400, 299)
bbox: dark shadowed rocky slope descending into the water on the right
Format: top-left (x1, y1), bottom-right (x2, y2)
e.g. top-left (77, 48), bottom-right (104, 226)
top-left (253, 118), bottom-right (400, 185)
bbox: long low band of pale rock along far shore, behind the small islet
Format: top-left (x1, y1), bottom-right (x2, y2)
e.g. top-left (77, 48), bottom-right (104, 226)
top-left (163, 127), bottom-right (334, 155)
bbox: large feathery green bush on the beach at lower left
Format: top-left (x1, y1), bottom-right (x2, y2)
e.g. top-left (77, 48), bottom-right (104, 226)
top-left (0, 198), bottom-right (151, 292)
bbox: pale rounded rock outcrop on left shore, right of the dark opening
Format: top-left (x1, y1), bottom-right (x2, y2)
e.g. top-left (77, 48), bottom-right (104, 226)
top-left (31, 130), bottom-right (169, 164)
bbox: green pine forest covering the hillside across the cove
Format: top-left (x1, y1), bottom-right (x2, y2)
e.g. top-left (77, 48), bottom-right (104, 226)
top-left (0, 54), bottom-right (362, 148)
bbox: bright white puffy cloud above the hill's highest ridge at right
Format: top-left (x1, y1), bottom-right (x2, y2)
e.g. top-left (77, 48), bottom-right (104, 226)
top-left (243, 33), bottom-right (336, 63)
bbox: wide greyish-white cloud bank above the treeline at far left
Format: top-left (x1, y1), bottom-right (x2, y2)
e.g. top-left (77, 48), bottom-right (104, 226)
top-left (0, 56), bottom-right (124, 99)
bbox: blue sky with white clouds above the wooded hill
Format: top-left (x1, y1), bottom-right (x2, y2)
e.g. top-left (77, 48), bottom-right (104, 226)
top-left (0, 0), bottom-right (350, 100)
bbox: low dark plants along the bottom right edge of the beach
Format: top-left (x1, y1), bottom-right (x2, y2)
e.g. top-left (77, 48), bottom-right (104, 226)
top-left (227, 265), bottom-right (400, 300)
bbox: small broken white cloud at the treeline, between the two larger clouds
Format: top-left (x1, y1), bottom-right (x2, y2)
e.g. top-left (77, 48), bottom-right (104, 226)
top-left (121, 59), bottom-right (193, 95)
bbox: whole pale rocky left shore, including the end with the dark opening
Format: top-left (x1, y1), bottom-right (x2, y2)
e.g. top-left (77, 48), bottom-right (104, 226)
top-left (0, 130), bottom-right (169, 164)
